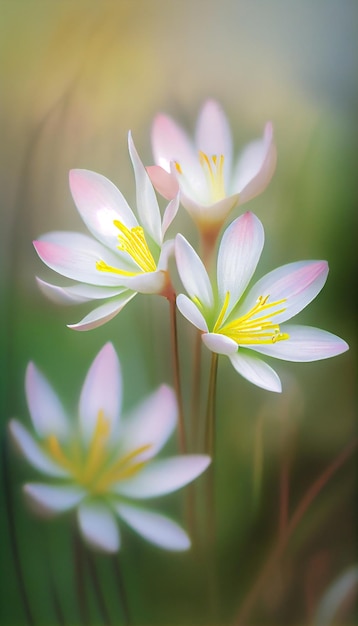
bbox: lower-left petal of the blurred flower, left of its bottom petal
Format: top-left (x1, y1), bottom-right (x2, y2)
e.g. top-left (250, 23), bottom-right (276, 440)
top-left (24, 483), bottom-right (86, 515)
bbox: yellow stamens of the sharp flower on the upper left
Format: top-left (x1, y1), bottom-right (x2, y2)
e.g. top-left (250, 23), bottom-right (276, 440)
top-left (96, 220), bottom-right (157, 276)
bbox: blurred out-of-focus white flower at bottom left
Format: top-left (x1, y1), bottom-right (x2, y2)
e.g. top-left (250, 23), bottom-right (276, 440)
top-left (9, 343), bottom-right (210, 552)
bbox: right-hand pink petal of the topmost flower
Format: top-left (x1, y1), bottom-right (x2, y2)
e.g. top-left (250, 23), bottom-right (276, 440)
top-left (231, 122), bottom-right (277, 204)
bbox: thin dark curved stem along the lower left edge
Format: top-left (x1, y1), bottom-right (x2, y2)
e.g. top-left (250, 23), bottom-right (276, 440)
top-left (2, 436), bottom-right (35, 626)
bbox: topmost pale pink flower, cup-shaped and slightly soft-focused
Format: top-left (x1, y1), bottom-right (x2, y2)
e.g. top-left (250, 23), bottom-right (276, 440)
top-left (147, 100), bottom-right (276, 231)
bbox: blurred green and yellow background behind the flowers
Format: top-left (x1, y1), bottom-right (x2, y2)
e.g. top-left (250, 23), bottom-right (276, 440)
top-left (0, 0), bottom-right (358, 626)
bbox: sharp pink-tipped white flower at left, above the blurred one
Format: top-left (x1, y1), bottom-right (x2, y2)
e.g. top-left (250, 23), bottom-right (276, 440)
top-left (34, 134), bottom-right (179, 330)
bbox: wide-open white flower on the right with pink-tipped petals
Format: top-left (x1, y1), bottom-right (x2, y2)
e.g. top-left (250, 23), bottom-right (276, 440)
top-left (175, 213), bottom-right (348, 392)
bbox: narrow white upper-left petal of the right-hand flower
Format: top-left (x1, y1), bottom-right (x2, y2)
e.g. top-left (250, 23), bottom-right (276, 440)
top-left (175, 234), bottom-right (214, 308)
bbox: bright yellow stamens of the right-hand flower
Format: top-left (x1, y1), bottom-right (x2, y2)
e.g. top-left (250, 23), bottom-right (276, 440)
top-left (213, 292), bottom-right (289, 346)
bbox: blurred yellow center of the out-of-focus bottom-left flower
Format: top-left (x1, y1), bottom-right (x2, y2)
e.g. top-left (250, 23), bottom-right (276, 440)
top-left (45, 411), bottom-right (151, 495)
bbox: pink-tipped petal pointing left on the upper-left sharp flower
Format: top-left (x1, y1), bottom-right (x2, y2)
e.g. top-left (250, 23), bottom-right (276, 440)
top-left (33, 232), bottom-right (134, 287)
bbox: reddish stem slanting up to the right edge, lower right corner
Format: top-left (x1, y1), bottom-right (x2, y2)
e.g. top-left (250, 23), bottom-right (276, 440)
top-left (234, 440), bottom-right (358, 626)
